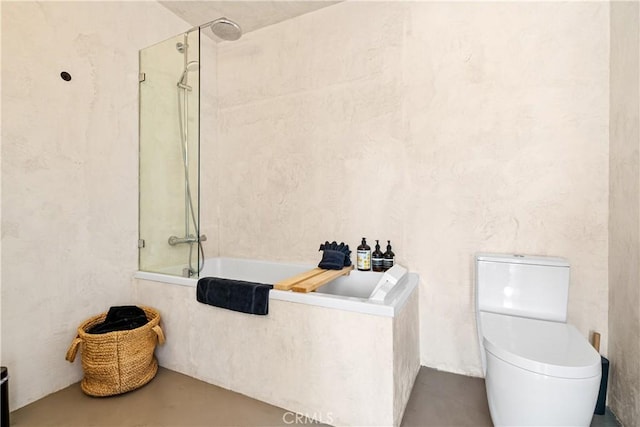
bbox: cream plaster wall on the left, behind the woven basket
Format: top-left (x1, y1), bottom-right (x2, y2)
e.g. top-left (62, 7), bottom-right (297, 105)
top-left (1, 2), bottom-right (189, 410)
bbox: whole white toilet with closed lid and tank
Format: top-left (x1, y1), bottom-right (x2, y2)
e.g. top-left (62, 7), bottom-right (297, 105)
top-left (475, 253), bottom-right (601, 426)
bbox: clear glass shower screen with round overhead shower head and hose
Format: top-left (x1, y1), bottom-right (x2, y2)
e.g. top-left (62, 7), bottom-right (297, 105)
top-left (138, 17), bottom-right (242, 277)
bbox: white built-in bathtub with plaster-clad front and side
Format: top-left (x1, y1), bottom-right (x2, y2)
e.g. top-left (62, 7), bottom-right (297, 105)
top-left (134, 258), bottom-right (420, 426)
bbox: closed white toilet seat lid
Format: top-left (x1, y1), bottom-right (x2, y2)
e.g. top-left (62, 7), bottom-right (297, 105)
top-left (480, 312), bottom-right (601, 379)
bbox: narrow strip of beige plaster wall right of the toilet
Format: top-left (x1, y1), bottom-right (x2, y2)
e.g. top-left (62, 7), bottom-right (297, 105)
top-left (609, 2), bottom-right (640, 426)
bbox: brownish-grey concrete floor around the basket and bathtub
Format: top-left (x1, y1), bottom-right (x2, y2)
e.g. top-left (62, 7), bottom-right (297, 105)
top-left (9, 367), bottom-right (619, 427)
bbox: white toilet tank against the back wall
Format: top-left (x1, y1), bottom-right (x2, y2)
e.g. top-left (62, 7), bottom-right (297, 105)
top-left (476, 253), bottom-right (569, 322)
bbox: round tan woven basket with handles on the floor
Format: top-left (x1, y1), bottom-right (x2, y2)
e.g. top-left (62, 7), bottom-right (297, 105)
top-left (66, 307), bottom-right (165, 396)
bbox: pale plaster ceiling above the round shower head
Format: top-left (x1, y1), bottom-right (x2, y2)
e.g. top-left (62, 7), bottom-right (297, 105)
top-left (159, 0), bottom-right (339, 39)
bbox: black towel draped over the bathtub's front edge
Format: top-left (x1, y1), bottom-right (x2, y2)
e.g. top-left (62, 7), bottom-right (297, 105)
top-left (196, 277), bottom-right (273, 315)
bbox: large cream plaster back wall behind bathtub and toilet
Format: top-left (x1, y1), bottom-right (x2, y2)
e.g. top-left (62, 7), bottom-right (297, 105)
top-left (214, 2), bottom-right (609, 375)
